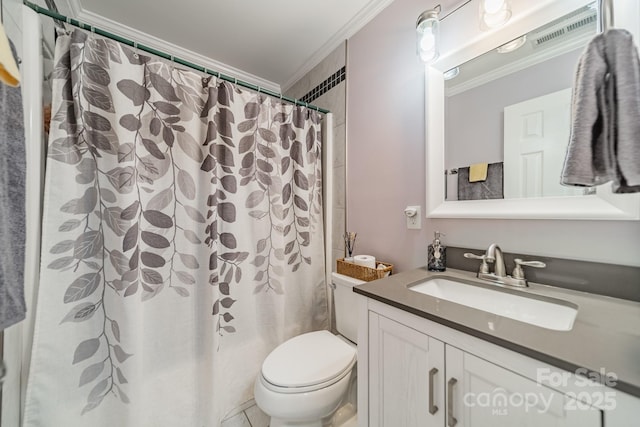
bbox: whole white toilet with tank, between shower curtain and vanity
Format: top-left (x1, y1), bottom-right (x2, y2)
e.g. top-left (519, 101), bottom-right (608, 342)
top-left (254, 273), bottom-right (365, 427)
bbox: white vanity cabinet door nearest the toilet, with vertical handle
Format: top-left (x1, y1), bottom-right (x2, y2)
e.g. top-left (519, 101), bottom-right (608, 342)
top-left (369, 312), bottom-right (445, 427)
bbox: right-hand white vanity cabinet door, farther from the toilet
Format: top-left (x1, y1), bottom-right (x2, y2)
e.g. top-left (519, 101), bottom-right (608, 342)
top-left (445, 345), bottom-right (602, 427)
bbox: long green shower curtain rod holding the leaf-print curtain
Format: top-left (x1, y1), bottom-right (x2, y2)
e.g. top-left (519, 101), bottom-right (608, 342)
top-left (23, 0), bottom-right (330, 114)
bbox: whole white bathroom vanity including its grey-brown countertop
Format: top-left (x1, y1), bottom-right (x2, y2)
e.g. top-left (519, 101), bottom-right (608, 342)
top-left (354, 268), bottom-right (640, 427)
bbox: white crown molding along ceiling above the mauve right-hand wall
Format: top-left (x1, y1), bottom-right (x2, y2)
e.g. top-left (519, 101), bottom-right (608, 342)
top-left (281, 0), bottom-right (393, 93)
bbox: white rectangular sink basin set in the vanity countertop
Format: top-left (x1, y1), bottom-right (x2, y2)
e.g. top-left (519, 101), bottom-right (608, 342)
top-left (409, 277), bottom-right (578, 331)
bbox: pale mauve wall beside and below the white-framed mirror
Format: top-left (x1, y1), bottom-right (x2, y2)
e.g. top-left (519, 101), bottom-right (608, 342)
top-left (347, 0), bottom-right (640, 271)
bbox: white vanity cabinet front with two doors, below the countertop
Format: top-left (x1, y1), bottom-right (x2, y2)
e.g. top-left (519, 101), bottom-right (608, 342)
top-left (358, 298), bottom-right (640, 427)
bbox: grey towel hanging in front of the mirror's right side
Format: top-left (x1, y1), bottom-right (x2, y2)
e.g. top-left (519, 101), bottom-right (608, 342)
top-left (560, 29), bottom-right (640, 193)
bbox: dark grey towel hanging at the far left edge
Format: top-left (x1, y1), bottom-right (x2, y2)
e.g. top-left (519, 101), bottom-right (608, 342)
top-left (0, 39), bottom-right (26, 330)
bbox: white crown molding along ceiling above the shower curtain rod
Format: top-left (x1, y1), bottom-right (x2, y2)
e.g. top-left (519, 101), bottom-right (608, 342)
top-left (63, 0), bottom-right (280, 93)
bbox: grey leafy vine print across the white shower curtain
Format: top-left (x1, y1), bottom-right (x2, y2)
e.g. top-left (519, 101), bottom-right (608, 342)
top-left (43, 30), bottom-right (324, 414)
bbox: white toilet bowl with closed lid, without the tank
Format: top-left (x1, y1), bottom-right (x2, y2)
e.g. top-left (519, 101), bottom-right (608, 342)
top-left (254, 331), bottom-right (356, 427)
